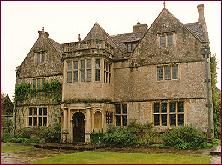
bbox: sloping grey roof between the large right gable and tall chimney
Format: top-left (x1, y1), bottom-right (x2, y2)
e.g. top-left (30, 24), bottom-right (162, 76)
top-left (184, 22), bottom-right (206, 42)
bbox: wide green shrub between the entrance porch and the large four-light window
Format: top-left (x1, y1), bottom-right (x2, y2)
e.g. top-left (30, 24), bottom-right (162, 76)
top-left (91, 122), bottom-right (157, 147)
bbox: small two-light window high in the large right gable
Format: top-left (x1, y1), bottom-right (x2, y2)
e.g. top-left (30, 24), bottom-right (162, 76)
top-left (159, 33), bottom-right (173, 48)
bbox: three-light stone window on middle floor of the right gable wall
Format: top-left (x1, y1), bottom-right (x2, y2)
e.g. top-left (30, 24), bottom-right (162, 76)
top-left (156, 63), bottom-right (179, 81)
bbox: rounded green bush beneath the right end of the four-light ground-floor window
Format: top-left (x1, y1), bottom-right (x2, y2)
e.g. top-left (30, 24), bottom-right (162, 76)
top-left (162, 126), bottom-right (207, 149)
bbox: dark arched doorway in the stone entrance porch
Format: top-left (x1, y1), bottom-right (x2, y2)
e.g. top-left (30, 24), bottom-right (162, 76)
top-left (72, 112), bottom-right (85, 143)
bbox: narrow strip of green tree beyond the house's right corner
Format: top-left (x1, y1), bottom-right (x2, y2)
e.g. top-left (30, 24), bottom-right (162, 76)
top-left (210, 54), bottom-right (221, 138)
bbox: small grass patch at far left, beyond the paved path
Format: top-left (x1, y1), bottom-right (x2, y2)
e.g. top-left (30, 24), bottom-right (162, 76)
top-left (1, 143), bottom-right (34, 153)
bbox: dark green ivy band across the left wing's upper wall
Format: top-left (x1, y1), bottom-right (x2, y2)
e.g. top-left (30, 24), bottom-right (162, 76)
top-left (15, 80), bottom-right (62, 103)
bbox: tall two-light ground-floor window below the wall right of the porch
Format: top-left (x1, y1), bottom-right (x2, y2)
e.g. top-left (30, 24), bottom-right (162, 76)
top-left (115, 103), bottom-right (128, 127)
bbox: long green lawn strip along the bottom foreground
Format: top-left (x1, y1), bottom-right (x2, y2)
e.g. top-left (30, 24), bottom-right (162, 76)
top-left (31, 151), bottom-right (210, 164)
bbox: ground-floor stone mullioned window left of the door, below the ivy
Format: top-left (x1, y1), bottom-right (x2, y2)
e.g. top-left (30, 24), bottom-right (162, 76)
top-left (27, 106), bottom-right (48, 127)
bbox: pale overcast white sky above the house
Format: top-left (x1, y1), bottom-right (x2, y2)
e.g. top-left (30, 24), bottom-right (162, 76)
top-left (1, 1), bottom-right (221, 98)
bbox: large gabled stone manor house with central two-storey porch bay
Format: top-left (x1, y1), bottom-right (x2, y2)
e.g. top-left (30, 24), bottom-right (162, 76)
top-left (16, 4), bottom-right (212, 143)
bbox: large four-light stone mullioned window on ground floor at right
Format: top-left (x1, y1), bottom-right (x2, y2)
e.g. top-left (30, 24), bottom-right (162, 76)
top-left (152, 100), bottom-right (185, 128)
